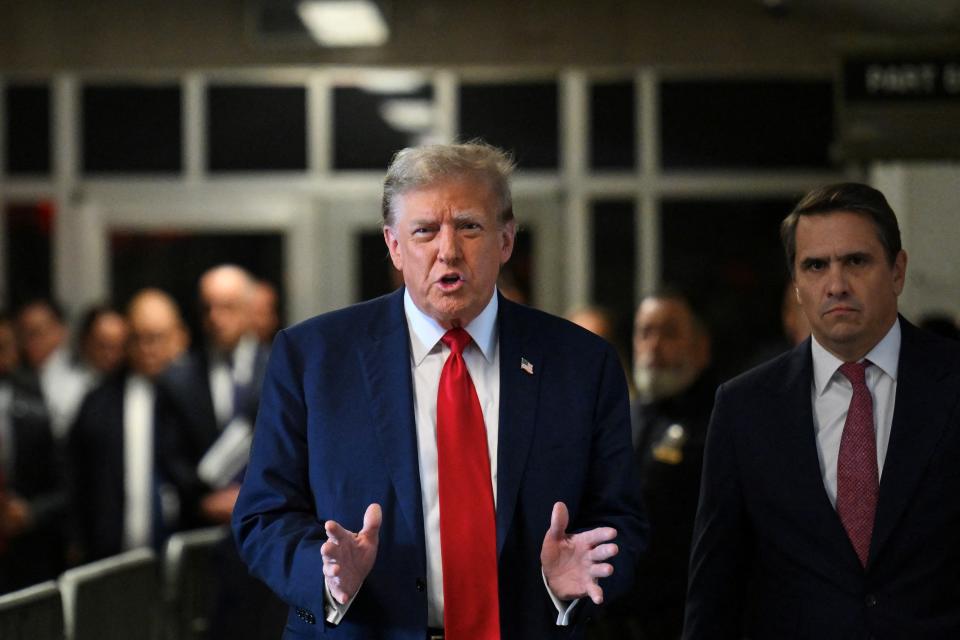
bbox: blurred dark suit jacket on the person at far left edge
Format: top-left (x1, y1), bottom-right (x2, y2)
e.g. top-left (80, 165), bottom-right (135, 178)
top-left (0, 378), bottom-right (67, 593)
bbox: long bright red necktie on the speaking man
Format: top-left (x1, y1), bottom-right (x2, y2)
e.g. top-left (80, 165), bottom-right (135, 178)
top-left (437, 328), bottom-right (500, 640)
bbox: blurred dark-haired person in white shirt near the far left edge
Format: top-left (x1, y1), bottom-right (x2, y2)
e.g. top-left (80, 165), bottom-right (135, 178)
top-left (16, 299), bottom-right (87, 441)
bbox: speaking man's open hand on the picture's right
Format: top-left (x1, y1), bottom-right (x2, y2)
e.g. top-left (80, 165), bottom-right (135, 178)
top-left (540, 502), bottom-right (618, 604)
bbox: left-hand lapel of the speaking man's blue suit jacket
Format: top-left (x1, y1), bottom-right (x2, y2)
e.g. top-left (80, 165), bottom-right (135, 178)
top-left (360, 289), bottom-right (425, 550)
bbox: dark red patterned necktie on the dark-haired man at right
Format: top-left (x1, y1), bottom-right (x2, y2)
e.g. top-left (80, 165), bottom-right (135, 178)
top-left (837, 360), bottom-right (880, 567)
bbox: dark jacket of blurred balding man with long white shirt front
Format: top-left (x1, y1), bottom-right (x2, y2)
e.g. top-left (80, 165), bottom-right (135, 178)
top-left (69, 372), bottom-right (198, 561)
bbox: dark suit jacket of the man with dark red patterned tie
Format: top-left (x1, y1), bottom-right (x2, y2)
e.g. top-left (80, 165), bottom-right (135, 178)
top-left (684, 318), bottom-right (960, 640)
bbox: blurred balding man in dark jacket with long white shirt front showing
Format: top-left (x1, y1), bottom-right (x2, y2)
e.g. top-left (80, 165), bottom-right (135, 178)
top-left (68, 289), bottom-right (198, 562)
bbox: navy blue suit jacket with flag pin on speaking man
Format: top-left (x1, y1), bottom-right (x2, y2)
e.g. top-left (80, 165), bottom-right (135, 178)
top-left (234, 290), bottom-right (646, 640)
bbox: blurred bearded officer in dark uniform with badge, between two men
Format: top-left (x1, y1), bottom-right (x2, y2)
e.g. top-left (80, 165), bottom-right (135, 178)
top-left (591, 287), bottom-right (716, 640)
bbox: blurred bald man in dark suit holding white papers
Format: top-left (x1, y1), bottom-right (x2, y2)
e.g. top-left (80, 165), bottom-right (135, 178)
top-left (160, 265), bottom-right (286, 640)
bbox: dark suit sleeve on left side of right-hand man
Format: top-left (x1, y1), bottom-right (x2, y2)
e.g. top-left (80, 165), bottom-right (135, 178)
top-left (683, 386), bottom-right (753, 640)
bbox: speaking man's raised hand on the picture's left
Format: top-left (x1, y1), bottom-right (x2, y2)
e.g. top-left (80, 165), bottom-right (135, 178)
top-left (320, 503), bottom-right (383, 604)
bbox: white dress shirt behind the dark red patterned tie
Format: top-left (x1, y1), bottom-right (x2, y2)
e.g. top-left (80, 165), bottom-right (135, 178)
top-left (811, 319), bottom-right (900, 507)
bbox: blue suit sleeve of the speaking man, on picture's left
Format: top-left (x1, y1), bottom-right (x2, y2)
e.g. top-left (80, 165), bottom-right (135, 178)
top-left (233, 332), bottom-right (326, 617)
